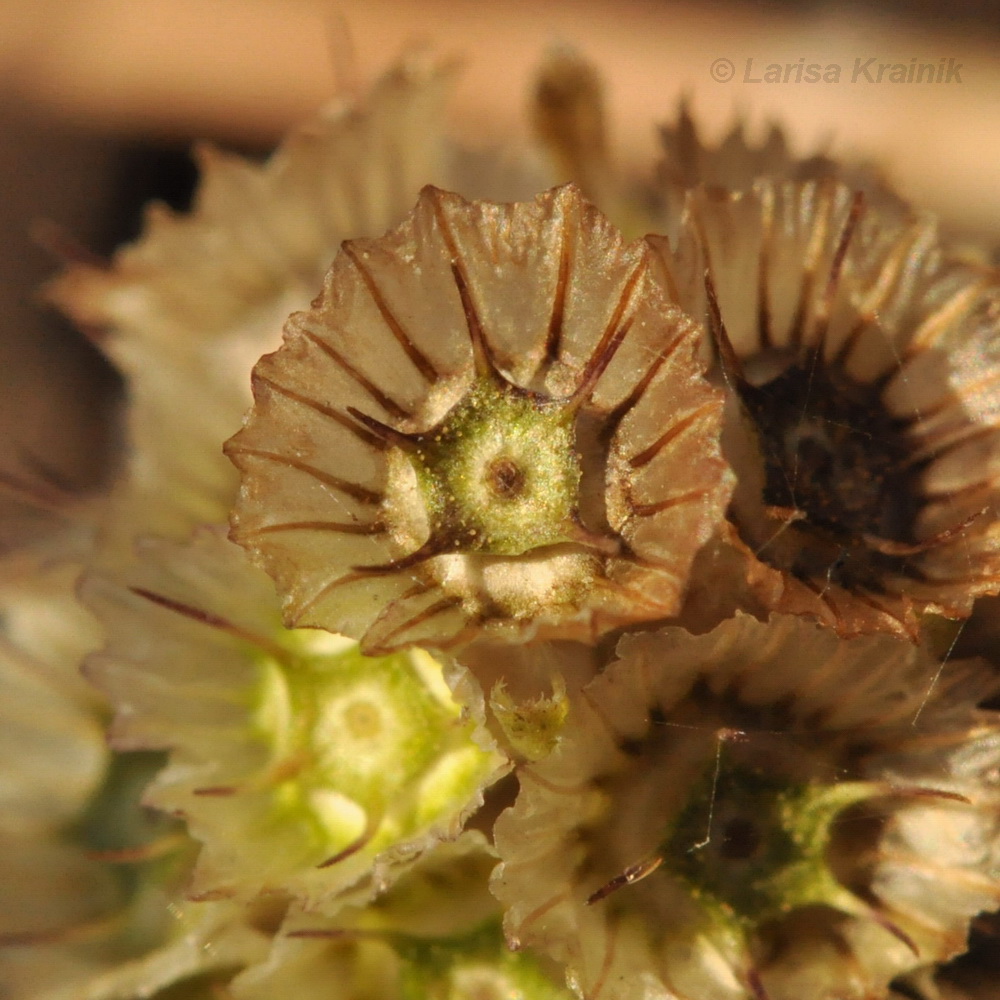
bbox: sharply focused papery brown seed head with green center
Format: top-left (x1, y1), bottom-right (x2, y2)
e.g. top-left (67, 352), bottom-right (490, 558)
top-left (227, 187), bottom-right (730, 652)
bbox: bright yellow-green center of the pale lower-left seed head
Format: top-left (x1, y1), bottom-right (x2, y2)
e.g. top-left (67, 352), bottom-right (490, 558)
top-left (250, 633), bottom-right (493, 853)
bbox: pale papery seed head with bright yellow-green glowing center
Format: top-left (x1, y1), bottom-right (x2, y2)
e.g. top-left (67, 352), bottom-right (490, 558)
top-left (79, 530), bottom-right (503, 903)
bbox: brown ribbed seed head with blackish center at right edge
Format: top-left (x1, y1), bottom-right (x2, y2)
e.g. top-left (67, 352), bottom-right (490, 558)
top-left (651, 181), bottom-right (1000, 636)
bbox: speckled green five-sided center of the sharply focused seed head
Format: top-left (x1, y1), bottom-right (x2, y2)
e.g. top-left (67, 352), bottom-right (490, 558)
top-left (412, 381), bottom-right (581, 556)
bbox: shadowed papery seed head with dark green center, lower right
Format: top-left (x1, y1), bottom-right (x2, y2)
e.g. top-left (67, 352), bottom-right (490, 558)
top-left (495, 615), bottom-right (1000, 1000)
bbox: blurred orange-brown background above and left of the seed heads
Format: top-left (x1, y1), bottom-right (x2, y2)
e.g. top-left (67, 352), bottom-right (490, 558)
top-left (0, 0), bottom-right (1000, 544)
